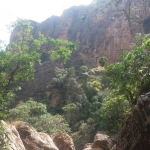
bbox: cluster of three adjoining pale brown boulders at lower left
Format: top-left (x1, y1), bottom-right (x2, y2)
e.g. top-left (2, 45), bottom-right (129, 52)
top-left (0, 121), bottom-right (75, 150)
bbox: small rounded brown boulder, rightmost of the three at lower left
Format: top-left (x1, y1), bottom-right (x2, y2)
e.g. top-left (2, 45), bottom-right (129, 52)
top-left (53, 133), bottom-right (75, 150)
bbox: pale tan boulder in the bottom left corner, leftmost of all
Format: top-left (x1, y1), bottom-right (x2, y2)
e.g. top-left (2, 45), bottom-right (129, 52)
top-left (0, 121), bottom-right (26, 150)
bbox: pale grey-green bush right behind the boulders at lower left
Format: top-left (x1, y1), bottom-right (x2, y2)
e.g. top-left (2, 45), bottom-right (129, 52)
top-left (9, 100), bottom-right (70, 134)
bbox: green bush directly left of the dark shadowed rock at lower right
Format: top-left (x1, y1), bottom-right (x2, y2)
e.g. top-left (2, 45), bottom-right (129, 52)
top-left (100, 92), bottom-right (129, 133)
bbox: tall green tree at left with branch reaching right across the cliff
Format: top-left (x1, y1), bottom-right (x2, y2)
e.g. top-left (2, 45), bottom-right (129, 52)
top-left (0, 19), bottom-right (75, 119)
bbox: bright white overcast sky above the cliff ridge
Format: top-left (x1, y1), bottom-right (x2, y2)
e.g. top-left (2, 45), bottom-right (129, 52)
top-left (0, 0), bottom-right (92, 43)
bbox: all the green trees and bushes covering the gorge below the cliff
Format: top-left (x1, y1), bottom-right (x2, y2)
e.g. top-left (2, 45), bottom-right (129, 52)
top-left (0, 0), bottom-right (150, 149)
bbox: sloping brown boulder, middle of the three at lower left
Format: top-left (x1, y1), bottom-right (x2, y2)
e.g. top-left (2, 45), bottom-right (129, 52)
top-left (14, 122), bottom-right (58, 150)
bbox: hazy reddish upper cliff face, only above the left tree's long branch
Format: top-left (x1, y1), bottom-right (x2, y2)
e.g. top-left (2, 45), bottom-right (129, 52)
top-left (10, 5), bottom-right (130, 67)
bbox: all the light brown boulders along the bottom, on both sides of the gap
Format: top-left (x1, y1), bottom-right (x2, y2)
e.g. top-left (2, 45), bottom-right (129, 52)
top-left (1, 121), bottom-right (115, 150)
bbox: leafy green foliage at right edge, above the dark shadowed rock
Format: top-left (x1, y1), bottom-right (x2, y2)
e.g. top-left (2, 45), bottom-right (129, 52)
top-left (107, 35), bottom-right (150, 103)
